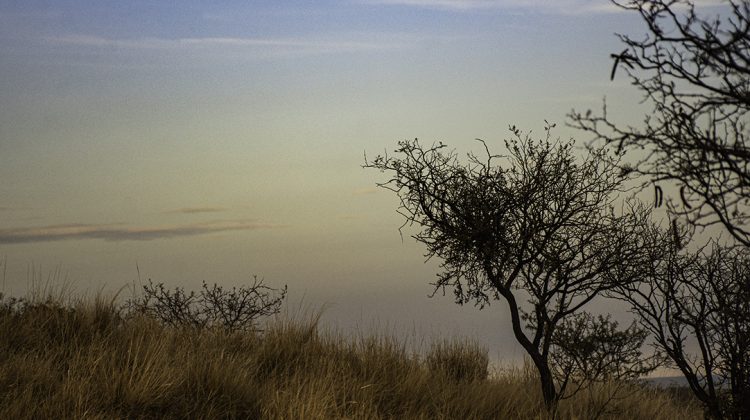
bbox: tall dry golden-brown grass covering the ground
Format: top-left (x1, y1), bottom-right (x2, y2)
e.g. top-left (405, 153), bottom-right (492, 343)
top-left (0, 298), bottom-right (702, 420)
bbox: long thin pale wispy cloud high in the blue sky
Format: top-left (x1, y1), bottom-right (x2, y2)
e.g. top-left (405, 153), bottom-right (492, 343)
top-left (46, 34), bottom-right (408, 54)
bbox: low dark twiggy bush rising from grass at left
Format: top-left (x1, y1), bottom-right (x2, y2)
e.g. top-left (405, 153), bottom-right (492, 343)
top-left (126, 276), bottom-right (287, 331)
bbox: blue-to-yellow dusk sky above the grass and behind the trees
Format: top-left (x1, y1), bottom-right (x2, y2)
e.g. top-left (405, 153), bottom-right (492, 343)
top-left (0, 0), bottom-right (728, 363)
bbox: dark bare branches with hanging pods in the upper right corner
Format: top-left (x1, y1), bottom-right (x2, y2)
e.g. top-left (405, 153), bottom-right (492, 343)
top-left (569, 0), bottom-right (750, 246)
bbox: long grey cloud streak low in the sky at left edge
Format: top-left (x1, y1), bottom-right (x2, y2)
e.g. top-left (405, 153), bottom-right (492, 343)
top-left (0, 220), bottom-right (283, 244)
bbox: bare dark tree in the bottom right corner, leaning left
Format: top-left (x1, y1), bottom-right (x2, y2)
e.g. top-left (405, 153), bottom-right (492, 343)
top-left (611, 232), bottom-right (750, 419)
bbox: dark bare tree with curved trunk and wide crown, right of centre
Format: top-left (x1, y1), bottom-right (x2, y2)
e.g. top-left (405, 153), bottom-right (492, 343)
top-left (365, 126), bottom-right (650, 410)
